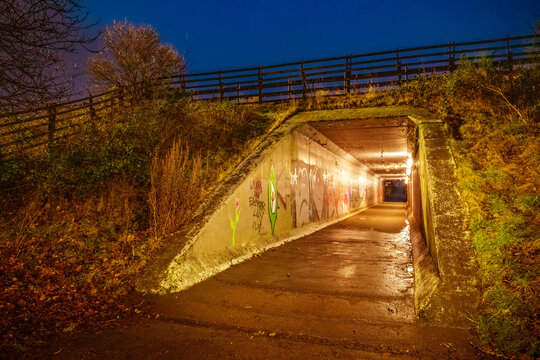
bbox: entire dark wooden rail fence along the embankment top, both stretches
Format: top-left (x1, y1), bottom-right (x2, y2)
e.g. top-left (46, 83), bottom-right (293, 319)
top-left (0, 35), bottom-right (540, 157)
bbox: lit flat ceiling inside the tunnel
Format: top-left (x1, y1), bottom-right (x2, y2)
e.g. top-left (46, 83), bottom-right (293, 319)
top-left (310, 118), bottom-right (409, 177)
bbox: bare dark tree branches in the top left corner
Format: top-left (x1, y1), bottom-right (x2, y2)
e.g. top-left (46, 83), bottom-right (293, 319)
top-left (0, 0), bottom-right (94, 112)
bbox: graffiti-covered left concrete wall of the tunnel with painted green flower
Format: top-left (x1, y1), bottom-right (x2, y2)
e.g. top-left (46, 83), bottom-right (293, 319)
top-left (159, 126), bottom-right (382, 292)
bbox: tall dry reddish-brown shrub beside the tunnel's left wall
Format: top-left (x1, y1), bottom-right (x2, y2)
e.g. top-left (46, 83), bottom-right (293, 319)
top-left (149, 139), bottom-right (201, 238)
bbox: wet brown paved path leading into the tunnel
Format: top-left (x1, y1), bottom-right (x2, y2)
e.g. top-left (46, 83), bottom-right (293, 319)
top-left (43, 203), bottom-right (476, 359)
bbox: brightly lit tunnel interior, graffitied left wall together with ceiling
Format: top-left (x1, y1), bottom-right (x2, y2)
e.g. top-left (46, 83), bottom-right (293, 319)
top-left (150, 117), bottom-right (420, 291)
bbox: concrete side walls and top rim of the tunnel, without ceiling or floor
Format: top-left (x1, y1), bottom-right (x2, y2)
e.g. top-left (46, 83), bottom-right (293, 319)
top-left (138, 106), bottom-right (479, 326)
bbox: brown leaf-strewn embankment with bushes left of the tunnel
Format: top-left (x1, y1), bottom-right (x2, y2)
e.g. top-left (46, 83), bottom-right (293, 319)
top-left (0, 99), bottom-right (292, 352)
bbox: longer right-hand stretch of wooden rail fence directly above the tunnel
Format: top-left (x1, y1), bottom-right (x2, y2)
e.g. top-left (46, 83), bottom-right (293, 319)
top-left (172, 35), bottom-right (539, 103)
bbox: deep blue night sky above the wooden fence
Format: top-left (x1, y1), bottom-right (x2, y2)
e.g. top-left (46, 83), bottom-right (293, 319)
top-left (82, 0), bottom-right (540, 73)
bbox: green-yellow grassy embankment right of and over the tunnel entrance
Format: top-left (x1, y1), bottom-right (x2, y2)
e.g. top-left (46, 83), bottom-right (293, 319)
top-left (304, 59), bottom-right (540, 357)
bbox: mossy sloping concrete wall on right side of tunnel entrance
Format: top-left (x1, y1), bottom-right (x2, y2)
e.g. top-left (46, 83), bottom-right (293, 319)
top-left (411, 121), bottom-right (478, 326)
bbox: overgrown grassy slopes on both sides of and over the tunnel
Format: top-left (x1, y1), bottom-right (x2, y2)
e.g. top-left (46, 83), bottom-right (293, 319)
top-left (0, 61), bottom-right (540, 355)
